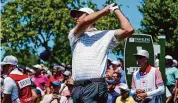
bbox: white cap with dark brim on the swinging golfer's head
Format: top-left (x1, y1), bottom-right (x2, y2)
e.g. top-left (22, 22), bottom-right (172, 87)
top-left (70, 7), bottom-right (94, 18)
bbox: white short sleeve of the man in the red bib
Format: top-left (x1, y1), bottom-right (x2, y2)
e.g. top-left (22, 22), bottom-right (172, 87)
top-left (3, 77), bottom-right (16, 94)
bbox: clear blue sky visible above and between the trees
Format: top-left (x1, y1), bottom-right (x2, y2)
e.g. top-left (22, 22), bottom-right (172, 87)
top-left (0, 0), bottom-right (143, 59)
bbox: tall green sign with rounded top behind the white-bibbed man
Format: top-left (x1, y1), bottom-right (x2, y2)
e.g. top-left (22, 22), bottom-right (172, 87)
top-left (124, 34), bottom-right (155, 86)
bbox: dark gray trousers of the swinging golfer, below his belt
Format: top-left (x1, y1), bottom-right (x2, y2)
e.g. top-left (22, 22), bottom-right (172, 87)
top-left (72, 82), bottom-right (108, 103)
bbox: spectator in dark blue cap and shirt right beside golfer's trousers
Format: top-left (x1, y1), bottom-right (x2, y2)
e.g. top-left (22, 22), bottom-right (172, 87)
top-left (107, 80), bottom-right (120, 103)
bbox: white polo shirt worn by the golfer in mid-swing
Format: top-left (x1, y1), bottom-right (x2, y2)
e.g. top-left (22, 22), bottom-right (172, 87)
top-left (68, 30), bottom-right (118, 81)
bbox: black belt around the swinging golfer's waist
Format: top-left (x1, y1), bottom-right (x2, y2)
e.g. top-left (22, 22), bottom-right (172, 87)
top-left (74, 78), bottom-right (105, 86)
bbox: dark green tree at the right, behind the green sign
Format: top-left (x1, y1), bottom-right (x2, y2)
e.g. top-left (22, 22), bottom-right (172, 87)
top-left (139, 0), bottom-right (178, 59)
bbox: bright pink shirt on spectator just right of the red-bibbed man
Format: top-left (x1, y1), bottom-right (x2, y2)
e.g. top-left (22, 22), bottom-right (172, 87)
top-left (34, 75), bottom-right (48, 90)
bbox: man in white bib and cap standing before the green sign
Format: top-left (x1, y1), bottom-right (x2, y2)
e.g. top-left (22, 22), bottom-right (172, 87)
top-left (132, 50), bottom-right (164, 103)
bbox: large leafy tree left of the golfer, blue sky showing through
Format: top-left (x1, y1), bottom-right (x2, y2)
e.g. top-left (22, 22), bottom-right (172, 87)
top-left (1, 0), bottom-right (76, 65)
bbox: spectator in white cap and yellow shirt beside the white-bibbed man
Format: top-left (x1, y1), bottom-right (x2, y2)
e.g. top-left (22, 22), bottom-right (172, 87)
top-left (115, 83), bottom-right (135, 103)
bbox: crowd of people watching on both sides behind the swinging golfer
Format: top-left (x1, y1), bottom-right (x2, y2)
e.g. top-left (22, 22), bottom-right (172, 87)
top-left (0, 52), bottom-right (178, 103)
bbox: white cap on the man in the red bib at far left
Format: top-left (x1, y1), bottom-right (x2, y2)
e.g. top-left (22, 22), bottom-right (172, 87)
top-left (1, 55), bottom-right (18, 65)
